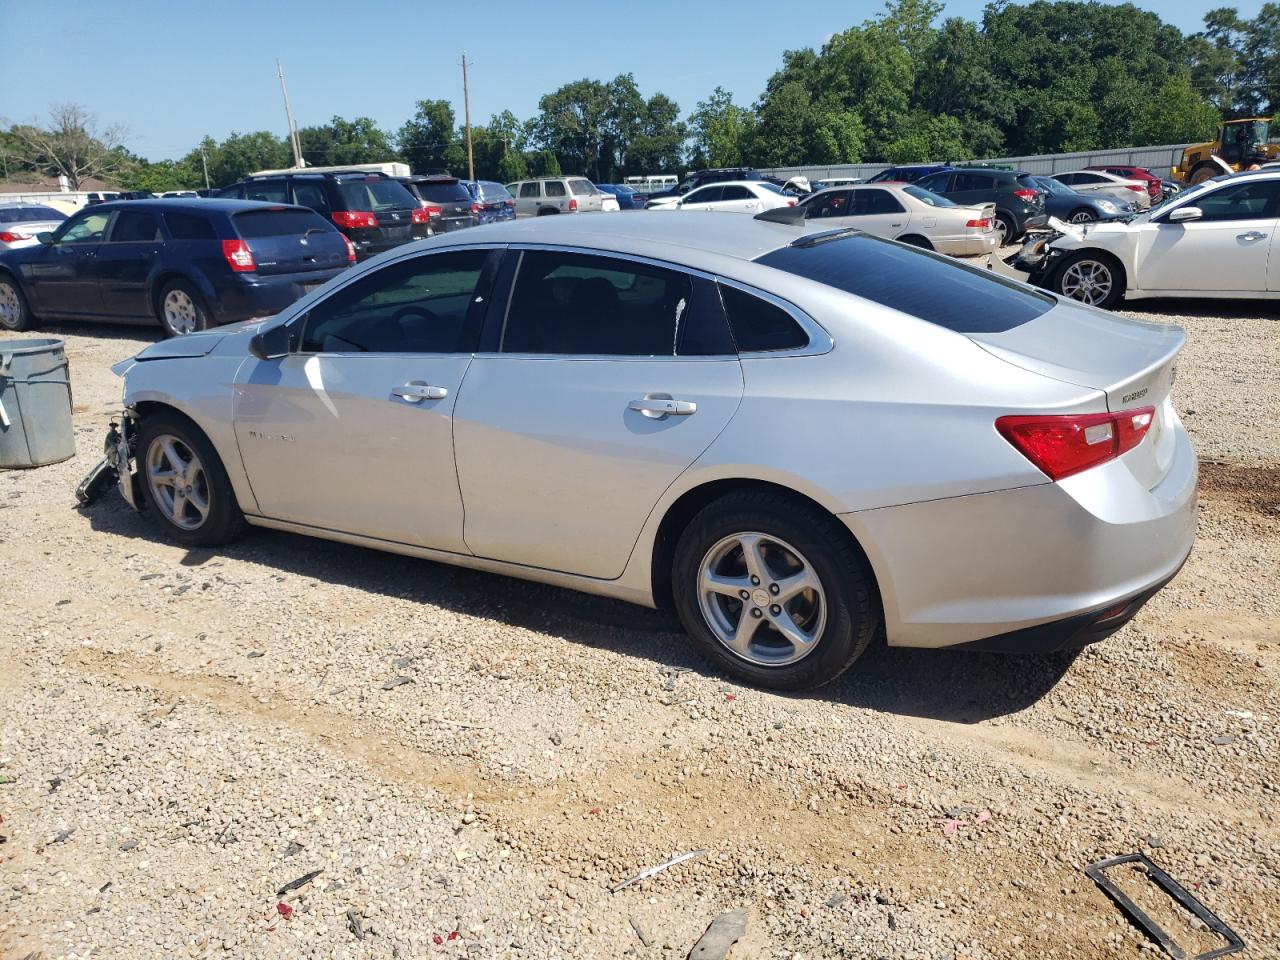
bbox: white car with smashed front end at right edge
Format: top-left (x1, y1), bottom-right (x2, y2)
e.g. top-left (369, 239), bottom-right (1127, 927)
top-left (1014, 170), bottom-right (1280, 307)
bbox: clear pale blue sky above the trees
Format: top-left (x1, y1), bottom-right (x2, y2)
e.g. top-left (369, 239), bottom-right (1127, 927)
top-left (0, 0), bottom-right (1261, 160)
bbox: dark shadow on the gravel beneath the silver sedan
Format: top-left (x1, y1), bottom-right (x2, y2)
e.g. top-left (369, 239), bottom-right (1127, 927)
top-left (79, 492), bottom-right (1074, 723)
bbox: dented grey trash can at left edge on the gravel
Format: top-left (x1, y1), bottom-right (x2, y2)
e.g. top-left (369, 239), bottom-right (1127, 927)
top-left (0, 338), bottom-right (76, 468)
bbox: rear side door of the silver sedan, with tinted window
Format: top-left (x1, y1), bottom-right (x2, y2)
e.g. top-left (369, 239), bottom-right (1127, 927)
top-left (454, 250), bottom-right (742, 579)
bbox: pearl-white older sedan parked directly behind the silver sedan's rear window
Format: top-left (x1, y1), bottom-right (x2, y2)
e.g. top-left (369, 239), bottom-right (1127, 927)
top-left (800, 183), bottom-right (998, 257)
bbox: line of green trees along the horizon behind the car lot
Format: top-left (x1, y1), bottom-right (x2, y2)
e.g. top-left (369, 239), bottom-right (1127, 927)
top-left (0, 0), bottom-right (1280, 192)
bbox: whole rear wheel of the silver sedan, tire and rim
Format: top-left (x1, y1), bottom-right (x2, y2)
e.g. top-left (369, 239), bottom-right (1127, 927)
top-left (672, 490), bottom-right (881, 690)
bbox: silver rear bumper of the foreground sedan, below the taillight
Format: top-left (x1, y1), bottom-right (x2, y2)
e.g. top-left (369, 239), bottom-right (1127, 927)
top-left (841, 424), bottom-right (1197, 652)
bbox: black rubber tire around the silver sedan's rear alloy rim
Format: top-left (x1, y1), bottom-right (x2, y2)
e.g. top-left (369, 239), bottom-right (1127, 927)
top-left (672, 490), bottom-right (881, 690)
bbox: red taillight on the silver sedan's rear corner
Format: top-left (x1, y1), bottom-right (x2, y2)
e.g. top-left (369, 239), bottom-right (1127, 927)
top-left (996, 407), bottom-right (1156, 480)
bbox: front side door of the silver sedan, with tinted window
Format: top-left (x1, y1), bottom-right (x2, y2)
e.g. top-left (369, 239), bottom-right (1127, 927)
top-left (236, 248), bottom-right (500, 552)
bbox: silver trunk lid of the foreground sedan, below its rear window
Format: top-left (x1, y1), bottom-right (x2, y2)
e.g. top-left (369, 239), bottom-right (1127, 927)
top-left (969, 302), bottom-right (1187, 489)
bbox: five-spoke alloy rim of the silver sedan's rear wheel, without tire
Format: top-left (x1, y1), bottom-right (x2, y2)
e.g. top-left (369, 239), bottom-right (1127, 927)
top-left (698, 532), bottom-right (827, 667)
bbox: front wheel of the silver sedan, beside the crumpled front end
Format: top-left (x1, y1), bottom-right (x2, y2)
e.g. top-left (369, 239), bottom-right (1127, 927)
top-left (137, 412), bottom-right (246, 547)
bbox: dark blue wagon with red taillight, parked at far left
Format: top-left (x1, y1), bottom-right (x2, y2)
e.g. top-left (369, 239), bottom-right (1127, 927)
top-left (0, 200), bottom-right (356, 337)
